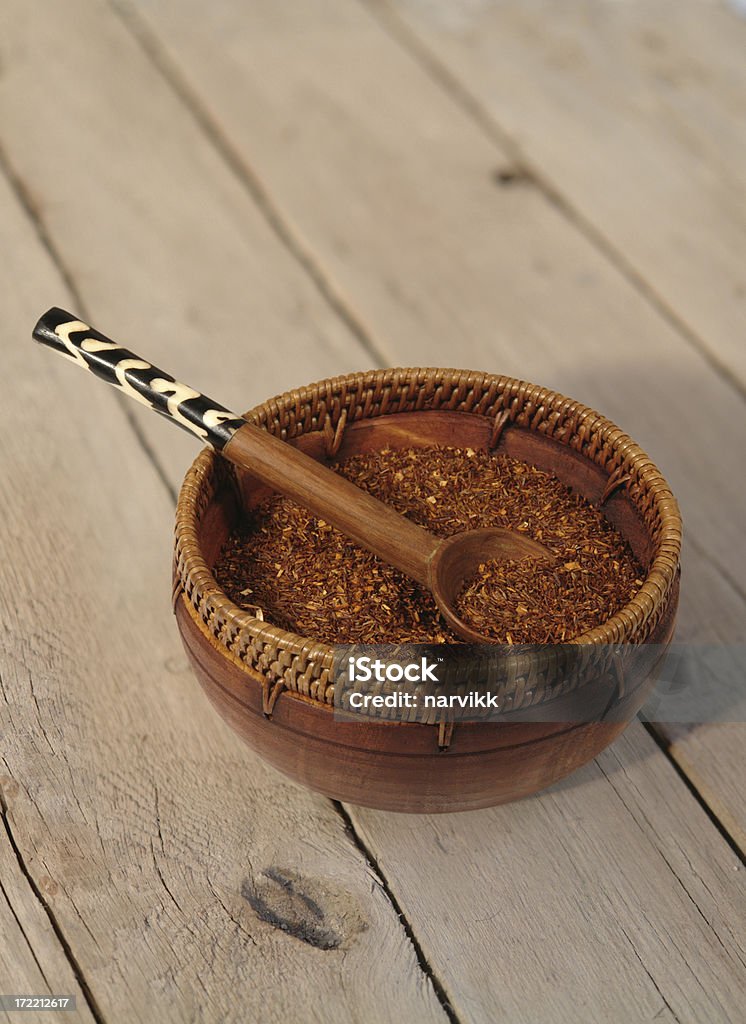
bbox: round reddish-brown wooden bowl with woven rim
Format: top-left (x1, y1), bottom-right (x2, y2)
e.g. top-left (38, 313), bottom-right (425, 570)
top-left (174, 369), bottom-right (682, 812)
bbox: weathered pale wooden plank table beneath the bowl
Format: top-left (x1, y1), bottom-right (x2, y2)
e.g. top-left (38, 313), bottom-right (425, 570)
top-left (0, 0), bottom-right (746, 1024)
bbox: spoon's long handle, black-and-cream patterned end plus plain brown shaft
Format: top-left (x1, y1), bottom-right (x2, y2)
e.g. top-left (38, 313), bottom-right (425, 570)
top-left (33, 308), bottom-right (440, 586)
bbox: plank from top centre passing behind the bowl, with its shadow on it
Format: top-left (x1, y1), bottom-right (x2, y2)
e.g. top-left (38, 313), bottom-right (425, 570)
top-left (110, 0), bottom-right (746, 836)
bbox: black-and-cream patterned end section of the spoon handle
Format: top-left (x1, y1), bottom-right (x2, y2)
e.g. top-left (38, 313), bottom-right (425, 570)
top-left (34, 307), bottom-right (246, 451)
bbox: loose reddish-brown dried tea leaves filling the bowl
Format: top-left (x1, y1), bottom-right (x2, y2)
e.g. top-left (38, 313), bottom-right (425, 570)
top-left (215, 447), bottom-right (642, 643)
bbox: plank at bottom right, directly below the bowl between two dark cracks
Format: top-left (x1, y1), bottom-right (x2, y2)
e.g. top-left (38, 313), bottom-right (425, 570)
top-left (352, 725), bottom-right (746, 1024)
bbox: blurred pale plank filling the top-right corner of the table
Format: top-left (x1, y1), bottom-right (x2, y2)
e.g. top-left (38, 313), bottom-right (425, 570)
top-left (380, 0), bottom-right (746, 393)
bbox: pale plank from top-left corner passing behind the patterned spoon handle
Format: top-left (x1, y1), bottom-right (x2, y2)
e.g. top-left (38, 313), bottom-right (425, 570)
top-left (0, 0), bottom-right (371, 481)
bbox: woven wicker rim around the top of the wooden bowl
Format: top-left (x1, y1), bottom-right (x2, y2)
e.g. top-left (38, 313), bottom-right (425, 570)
top-left (174, 367), bottom-right (682, 705)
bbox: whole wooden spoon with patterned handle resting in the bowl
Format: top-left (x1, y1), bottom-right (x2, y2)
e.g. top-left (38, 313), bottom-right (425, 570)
top-left (34, 308), bottom-right (554, 643)
